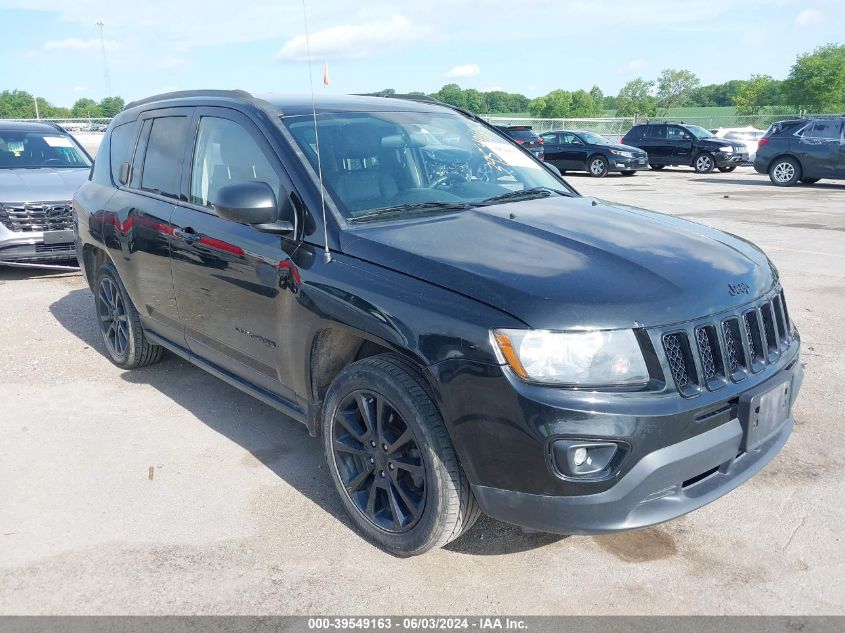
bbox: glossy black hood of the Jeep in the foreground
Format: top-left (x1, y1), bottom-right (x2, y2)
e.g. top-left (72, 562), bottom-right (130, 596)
top-left (341, 196), bottom-right (777, 329)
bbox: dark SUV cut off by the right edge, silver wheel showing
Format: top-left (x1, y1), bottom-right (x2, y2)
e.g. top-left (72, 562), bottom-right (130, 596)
top-left (754, 117), bottom-right (845, 187)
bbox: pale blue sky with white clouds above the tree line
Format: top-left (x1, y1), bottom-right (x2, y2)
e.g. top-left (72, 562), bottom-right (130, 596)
top-left (0, 0), bottom-right (845, 106)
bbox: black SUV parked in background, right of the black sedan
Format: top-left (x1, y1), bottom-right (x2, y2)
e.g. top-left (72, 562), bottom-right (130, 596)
top-left (620, 123), bottom-right (748, 174)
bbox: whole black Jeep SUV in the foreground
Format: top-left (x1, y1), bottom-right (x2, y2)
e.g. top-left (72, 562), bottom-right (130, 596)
top-left (74, 91), bottom-right (802, 555)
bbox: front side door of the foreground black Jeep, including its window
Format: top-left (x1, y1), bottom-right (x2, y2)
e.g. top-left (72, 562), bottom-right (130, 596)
top-left (172, 108), bottom-right (298, 402)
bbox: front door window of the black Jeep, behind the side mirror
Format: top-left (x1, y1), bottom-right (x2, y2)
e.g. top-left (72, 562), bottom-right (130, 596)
top-left (191, 117), bottom-right (281, 207)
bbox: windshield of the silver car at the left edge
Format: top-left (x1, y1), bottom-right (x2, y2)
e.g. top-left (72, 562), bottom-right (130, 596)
top-left (0, 129), bottom-right (91, 169)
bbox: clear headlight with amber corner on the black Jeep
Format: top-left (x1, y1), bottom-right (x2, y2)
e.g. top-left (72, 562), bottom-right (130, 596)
top-left (493, 330), bottom-right (649, 387)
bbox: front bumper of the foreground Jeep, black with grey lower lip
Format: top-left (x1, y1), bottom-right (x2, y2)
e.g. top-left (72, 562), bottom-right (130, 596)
top-left (435, 324), bottom-right (803, 534)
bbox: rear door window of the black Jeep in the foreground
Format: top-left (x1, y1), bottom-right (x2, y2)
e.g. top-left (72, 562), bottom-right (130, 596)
top-left (141, 116), bottom-right (188, 198)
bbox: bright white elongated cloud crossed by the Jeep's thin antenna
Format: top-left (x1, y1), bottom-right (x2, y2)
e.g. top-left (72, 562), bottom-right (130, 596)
top-left (276, 15), bottom-right (422, 62)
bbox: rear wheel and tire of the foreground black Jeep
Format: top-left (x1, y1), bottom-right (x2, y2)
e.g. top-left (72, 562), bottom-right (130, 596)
top-left (94, 264), bottom-right (164, 369)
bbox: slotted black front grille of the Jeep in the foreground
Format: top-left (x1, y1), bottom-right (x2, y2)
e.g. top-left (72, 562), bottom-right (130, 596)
top-left (662, 288), bottom-right (795, 396)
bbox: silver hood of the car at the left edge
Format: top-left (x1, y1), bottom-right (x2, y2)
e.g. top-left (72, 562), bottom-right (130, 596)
top-left (0, 167), bottom-right (91, 203)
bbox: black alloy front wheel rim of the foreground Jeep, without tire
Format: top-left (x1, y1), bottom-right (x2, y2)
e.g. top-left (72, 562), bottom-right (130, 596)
top-left (332, 390), bottom-right (426, 533)
